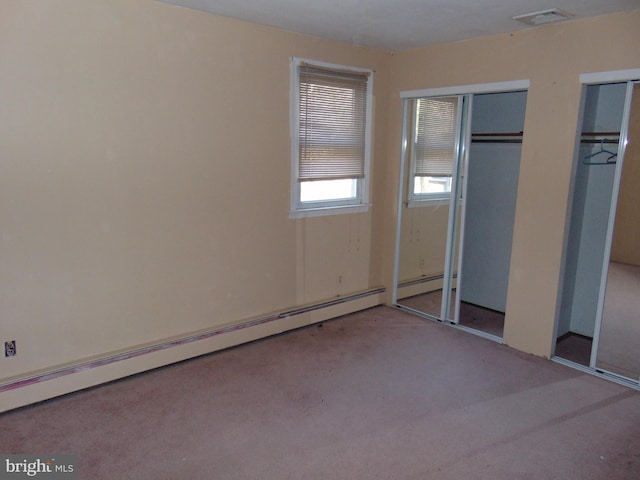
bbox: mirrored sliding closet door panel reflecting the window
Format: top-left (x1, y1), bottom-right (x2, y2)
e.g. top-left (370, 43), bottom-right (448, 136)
top-left (394, 95), bottom-right (467, 321)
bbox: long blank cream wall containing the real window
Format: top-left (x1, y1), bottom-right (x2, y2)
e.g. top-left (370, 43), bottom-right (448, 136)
top-left (0, 0), bottom-right (390, 383)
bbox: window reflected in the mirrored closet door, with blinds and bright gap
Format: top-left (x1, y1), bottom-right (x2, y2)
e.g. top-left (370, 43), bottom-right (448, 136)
top-left (409, 97), bottom-right (459, 203)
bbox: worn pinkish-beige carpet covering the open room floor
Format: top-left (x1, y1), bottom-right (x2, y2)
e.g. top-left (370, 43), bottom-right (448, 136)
top-left (0, 307), bottom-right (640, 480)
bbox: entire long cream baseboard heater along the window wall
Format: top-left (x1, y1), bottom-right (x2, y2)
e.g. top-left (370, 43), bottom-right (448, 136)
top-left (0, 287), bottom-right (385, 412)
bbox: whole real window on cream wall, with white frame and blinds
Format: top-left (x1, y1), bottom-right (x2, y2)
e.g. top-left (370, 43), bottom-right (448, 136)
top-left (291, 59), bottom-right (373, 217)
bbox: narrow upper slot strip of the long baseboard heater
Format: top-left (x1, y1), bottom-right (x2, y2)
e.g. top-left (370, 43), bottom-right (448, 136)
top-left (0, 287), bottom-right (386, 393)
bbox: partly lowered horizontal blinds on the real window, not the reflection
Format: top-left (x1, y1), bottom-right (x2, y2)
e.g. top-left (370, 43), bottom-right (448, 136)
top-left (298, 63), bottom-right (369, 181)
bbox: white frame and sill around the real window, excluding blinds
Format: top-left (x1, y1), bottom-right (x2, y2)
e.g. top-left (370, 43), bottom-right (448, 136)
top-left (289, 57), bottom-right (374, 218)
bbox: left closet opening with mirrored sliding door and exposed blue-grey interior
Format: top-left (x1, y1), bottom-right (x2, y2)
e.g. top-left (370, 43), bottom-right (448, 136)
top-left (394, 89), bottom-right (526, 340)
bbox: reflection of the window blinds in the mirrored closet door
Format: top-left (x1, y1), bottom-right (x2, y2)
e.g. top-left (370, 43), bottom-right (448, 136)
top-left (414, 97), bottom-right (458, 177)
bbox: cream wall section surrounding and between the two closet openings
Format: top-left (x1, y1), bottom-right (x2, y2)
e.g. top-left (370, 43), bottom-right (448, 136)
top-left (382, 10), bottom-right (640, 357)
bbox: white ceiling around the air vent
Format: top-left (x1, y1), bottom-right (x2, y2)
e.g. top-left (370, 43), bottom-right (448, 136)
top-left (159, 0), bottom-right (640, 51)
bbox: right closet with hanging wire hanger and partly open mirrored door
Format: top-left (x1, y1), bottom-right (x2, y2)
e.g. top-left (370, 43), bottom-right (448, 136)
top-left (555, 81), bottom-right (640, 384)
